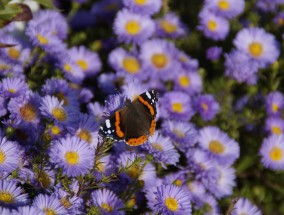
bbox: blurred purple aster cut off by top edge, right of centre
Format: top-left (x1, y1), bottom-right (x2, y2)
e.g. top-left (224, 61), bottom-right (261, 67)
top-left (205, 0), bottom-right (245, 19)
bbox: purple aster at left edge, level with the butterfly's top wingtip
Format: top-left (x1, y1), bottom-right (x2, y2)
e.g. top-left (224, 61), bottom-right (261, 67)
top-left (0, 78), bottom-right (28, 98)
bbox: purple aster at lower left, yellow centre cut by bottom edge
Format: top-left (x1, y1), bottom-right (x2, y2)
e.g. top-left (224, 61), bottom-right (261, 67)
top-left (33, 194), bottom-right (67, 215)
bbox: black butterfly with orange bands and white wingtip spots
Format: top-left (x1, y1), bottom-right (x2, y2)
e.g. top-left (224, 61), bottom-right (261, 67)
top-left (99, 90), bottom-right (158, 146)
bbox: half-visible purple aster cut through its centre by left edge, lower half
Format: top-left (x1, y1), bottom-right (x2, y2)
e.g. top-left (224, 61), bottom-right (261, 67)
top-left (0, 137), bottom-right (22, 172)
